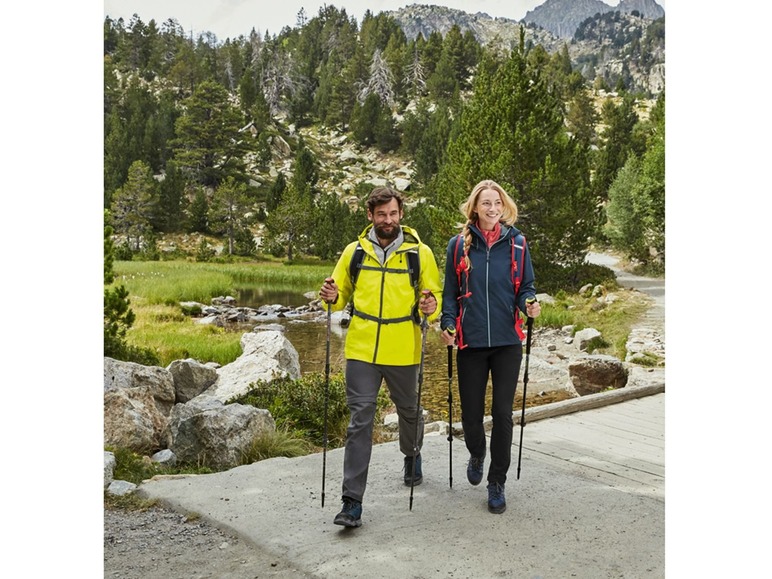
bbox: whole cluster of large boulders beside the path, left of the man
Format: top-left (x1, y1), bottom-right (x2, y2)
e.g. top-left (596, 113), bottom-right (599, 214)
top-left (104, 330), bottom-right (300, 466)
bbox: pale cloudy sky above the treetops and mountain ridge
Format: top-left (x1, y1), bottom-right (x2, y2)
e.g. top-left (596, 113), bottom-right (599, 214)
top-left (104, 0), bottom-right (665, 41)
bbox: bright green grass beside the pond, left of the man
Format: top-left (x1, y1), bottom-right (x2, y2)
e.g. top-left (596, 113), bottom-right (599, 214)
top-left (114, 260), bottom-right (332, 366)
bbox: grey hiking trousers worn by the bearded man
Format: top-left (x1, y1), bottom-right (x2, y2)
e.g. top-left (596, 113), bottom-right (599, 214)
top-left (343, 360), bottom-right (424, 501)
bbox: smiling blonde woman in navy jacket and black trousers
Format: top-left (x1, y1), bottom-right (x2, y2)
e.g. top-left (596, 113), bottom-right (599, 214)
top-left (440, 181), bottom-right (541, 513)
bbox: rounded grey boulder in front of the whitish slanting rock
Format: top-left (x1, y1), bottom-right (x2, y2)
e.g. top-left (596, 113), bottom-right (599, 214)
top-left (167, 396), bottom-right (276, 469)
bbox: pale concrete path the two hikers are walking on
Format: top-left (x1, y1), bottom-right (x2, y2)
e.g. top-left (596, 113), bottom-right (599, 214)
top-left (139, 392), bottom-right (665, 579)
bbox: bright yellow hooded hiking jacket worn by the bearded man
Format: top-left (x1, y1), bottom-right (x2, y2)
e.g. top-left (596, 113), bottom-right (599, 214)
top-left (332, 224), bottom-right (442, 366)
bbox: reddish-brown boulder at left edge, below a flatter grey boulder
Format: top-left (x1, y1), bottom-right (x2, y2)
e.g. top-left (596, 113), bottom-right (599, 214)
top-left (103, 386), bottom-right (166, 454)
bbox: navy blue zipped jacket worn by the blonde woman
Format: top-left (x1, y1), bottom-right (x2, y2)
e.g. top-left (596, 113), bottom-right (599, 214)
top-left (440, 223), bottom-right (536, 348)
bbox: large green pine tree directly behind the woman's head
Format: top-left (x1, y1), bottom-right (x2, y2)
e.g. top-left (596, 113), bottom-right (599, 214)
top-left (431, 41), bottom-right (600, 276)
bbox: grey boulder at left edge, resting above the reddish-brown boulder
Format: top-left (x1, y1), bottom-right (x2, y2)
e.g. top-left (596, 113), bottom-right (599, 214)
top-left (104, 357), bottom-right (176, 416)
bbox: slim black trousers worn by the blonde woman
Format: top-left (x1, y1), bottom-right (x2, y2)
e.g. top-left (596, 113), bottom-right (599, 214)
top-left (456, 344), bottom-right (523, 485)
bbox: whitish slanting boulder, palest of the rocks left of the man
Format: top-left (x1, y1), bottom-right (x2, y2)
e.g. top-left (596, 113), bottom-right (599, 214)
top-left (203, 330), bottom-right (300, 402)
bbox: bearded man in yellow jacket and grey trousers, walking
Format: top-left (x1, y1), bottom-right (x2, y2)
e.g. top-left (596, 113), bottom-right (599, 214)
top-left (320, 187), bottom-right (442, 527)
